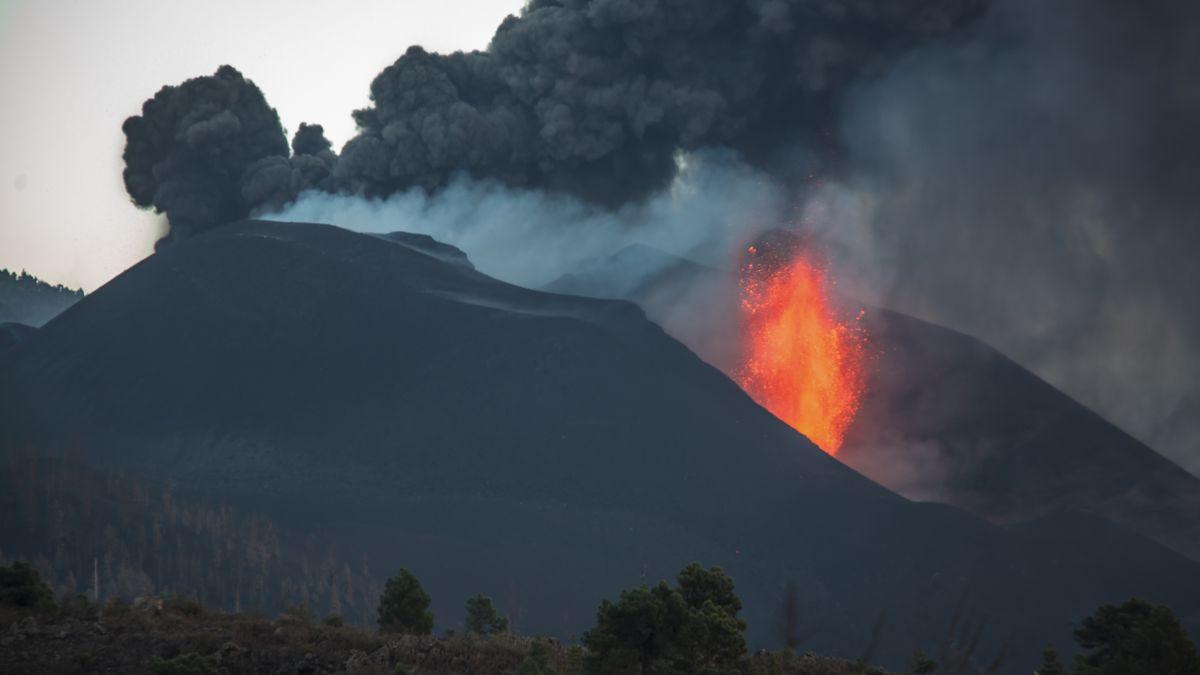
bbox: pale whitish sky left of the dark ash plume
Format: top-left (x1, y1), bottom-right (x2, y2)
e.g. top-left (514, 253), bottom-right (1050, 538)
top-left (0, 0), bottom-right (523, 291)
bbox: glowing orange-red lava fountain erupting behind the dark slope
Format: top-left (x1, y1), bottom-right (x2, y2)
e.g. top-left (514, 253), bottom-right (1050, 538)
top-left (737, 236), bottom-right (866, 454)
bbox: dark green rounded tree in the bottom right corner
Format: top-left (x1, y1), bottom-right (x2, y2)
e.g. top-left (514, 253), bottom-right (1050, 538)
top-left (1074, 598), bottom-right (1200, 675)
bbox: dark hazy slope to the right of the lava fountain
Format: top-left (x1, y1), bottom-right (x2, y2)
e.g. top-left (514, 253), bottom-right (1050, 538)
top-left (839, 311), bottom-right (1200, 560)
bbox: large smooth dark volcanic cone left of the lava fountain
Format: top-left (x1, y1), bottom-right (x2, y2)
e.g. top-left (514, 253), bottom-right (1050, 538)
top-left (0, 222), bottom-right (1200, 670)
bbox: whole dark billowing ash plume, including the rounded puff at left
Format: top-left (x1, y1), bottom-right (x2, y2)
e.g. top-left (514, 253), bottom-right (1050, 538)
top-left (125, 0), bottom-right (985, 237)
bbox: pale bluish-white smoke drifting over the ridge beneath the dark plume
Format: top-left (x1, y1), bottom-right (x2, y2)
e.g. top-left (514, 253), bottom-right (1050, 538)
top-left (266, 150), bottom-right (787, 288)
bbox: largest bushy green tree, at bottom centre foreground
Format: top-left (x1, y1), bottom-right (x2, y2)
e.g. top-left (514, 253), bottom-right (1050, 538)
top-left (583, 563), bottom-right (746, 673)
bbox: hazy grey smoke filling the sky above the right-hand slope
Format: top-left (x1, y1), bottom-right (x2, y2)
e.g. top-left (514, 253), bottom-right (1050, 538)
top-left (802, 0), bottom-right (1200, 473)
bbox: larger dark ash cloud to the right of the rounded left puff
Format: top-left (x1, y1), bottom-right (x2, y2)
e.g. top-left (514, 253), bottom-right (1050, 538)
top-left (336, 0), bottom-right (982, 205)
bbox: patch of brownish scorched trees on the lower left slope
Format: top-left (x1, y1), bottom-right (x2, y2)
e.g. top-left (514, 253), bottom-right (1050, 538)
top-left (0, 447), bottom-right (380, 625)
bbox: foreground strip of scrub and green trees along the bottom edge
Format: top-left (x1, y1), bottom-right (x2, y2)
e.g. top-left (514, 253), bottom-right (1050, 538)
top-left (0, 550), bottom-right (1200, 675)
